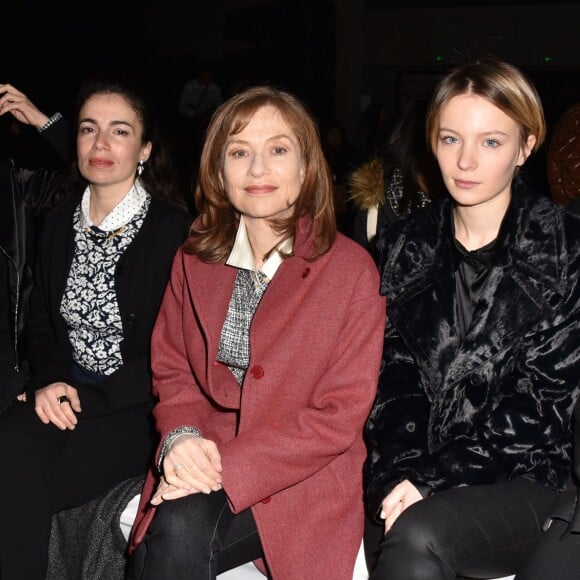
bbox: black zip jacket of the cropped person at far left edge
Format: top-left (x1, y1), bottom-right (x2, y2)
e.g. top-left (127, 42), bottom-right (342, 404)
top-left (0, 120), bottom-right (69, 412)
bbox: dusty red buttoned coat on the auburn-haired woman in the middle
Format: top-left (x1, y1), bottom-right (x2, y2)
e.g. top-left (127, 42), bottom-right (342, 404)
top-left (131, 220), bottom-right (385, 580)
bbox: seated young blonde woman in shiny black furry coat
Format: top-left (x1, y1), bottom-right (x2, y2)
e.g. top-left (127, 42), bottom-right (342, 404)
top-left (365, 59), bottom-right (580, 580)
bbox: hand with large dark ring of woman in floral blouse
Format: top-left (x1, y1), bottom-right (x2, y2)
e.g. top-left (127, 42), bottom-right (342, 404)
top-left (34, 383), bottom-right (81, 431)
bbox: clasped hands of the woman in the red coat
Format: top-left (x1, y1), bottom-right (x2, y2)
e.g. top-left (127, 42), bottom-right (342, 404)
top-left (151, 435), bottom-right (222, 505)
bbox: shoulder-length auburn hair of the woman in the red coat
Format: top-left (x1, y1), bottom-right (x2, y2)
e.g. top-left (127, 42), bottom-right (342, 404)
top-left (184, 86), bottom-right (336, 263)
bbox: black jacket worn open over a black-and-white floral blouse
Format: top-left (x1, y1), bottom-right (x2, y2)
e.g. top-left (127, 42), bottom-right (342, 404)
top-left (27, 195), bottom-right (190, 416)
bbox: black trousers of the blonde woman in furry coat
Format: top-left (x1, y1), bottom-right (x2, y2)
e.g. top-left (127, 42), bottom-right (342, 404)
top-left (370, 479), bottom-right (558, 580)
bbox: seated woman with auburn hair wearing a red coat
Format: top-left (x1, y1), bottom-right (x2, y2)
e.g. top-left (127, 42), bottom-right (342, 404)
top-left (130, 87), bottom-right (385, 580)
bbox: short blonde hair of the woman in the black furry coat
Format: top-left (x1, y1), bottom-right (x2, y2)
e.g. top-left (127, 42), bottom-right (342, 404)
top-left (427, 57), bottom-right (546, 152)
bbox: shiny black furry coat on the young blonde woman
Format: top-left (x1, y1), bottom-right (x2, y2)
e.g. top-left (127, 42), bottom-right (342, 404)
top-left (365, 184), bottom-right (580, 513)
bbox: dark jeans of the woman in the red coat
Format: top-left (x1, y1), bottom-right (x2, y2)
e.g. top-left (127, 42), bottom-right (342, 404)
top-left (129, 490), bottom-right (263, 580)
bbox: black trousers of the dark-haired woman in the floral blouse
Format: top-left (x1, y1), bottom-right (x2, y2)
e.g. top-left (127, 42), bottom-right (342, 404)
top-left (0, 402), bottom-right (154, 580)
